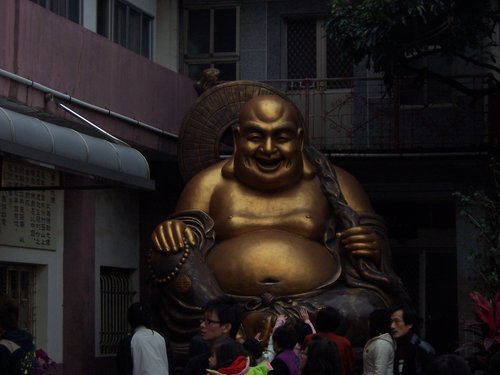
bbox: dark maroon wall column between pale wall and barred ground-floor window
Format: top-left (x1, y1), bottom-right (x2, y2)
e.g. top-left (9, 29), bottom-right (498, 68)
top-left (62, 187), bottom-right (97, 374)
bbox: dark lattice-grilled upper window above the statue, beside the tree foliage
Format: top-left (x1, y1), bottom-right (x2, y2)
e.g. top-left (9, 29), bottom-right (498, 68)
top-left (285, 18), bottom-right (353, 89)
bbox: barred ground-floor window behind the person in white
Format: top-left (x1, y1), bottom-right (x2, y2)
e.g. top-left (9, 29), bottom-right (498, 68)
top-left (99, 267), bottom-right (135, 355)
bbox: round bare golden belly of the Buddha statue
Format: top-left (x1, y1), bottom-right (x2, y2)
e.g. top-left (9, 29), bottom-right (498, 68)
top-left (207, 230), bottom-right (340, 295)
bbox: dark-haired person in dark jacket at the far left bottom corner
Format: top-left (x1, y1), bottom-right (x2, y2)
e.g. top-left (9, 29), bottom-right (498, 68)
top-left (0, 297), bottom-right (36, 375)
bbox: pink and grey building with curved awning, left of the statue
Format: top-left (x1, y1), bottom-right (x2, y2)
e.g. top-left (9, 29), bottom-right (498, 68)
top-left (0, 0), bottom-right (196, 374)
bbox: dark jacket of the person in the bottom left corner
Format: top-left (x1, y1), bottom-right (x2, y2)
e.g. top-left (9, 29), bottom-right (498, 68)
top-left (0, 329), bottom-right (36, 375)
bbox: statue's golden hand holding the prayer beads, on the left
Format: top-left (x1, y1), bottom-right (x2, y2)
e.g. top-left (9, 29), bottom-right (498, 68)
top-left (151, 220), bottom-right (196, 253)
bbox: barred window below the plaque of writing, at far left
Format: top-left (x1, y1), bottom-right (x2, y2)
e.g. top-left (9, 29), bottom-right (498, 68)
top-left (0, 263), bottom-right (36, 338)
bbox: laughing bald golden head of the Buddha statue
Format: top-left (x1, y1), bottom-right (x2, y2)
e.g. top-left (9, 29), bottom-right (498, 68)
top-left (234, 95), bottom-right (304, 190)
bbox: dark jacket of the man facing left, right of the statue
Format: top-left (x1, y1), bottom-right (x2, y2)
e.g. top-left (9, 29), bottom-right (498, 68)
top-left (394, 334), bottom-right (436, 375)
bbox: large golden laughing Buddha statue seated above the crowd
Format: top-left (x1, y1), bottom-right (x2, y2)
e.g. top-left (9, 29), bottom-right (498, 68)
top-left (150, 84), bottom-right (404, 352)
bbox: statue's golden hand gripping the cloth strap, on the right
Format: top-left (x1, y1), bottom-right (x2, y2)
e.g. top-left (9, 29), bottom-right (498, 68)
top-left (337, 225), bottom-right (380, 266)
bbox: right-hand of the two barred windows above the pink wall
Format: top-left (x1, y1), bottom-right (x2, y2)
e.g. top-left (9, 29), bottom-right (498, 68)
top-left (97, 0), bottom-right (153, 59)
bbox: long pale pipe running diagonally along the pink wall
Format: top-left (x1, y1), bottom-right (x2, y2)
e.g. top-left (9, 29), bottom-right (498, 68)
top-left (0, 69), bottom-right (179, 139)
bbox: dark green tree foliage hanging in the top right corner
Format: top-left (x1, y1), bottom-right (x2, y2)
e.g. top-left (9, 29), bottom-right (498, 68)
top-left (326, 0), bottom-right (500, 96)
